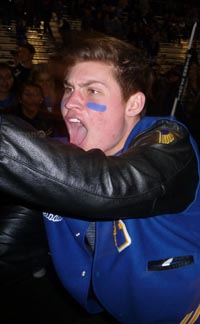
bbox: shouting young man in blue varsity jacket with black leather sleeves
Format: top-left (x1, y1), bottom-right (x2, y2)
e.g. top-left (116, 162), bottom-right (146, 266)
top-left (0, 36), bottom-right (200, 324)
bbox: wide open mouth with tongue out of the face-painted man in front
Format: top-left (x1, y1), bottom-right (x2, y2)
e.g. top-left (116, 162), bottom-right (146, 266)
top-left (68, 118), bottom-right (88, 146)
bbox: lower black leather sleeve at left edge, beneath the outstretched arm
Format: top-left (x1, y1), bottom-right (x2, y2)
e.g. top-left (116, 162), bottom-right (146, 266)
top-left (0, 200), bottom-right (49, 285)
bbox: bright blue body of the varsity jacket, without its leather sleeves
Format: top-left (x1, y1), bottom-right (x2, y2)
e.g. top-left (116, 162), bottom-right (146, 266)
top-left (41, 118), bottom-right (200, 324)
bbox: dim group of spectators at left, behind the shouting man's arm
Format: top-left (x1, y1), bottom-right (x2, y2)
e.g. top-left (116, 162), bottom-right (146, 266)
top-left (0, 43), bottom-right (67, 137)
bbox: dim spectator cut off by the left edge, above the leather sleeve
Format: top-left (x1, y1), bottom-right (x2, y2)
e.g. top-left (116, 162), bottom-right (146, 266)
top-left (0, 62), bottom-right (17, 114)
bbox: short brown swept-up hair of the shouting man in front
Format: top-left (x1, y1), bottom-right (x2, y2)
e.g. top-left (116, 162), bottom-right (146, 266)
top-left (61, 34), bottom-right (151, 100)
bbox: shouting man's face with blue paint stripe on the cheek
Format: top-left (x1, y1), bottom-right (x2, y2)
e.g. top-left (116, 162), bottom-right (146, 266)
top-left (61, 61), bottom-right (128, 155)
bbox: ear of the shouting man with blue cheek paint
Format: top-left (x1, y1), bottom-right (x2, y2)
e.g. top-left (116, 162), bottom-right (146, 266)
top-left (126, 92), bottom-right (145, 117)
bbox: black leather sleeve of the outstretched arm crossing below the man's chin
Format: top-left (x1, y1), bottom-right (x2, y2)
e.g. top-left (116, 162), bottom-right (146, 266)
top-left (0, 116), bottom-right (198, 220)
